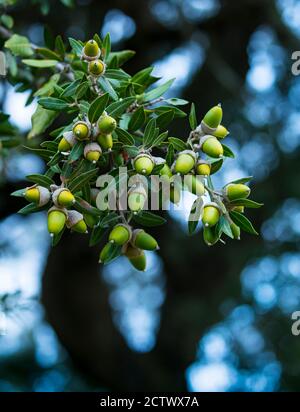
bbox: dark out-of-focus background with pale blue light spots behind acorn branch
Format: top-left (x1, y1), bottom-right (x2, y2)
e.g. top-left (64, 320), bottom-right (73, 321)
top-left (0, 0), bottom-right (300, 391)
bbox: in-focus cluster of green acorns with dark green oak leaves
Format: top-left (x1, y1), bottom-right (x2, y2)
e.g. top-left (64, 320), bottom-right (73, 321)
top-left (15, 36), bottom-right (261, 271)
